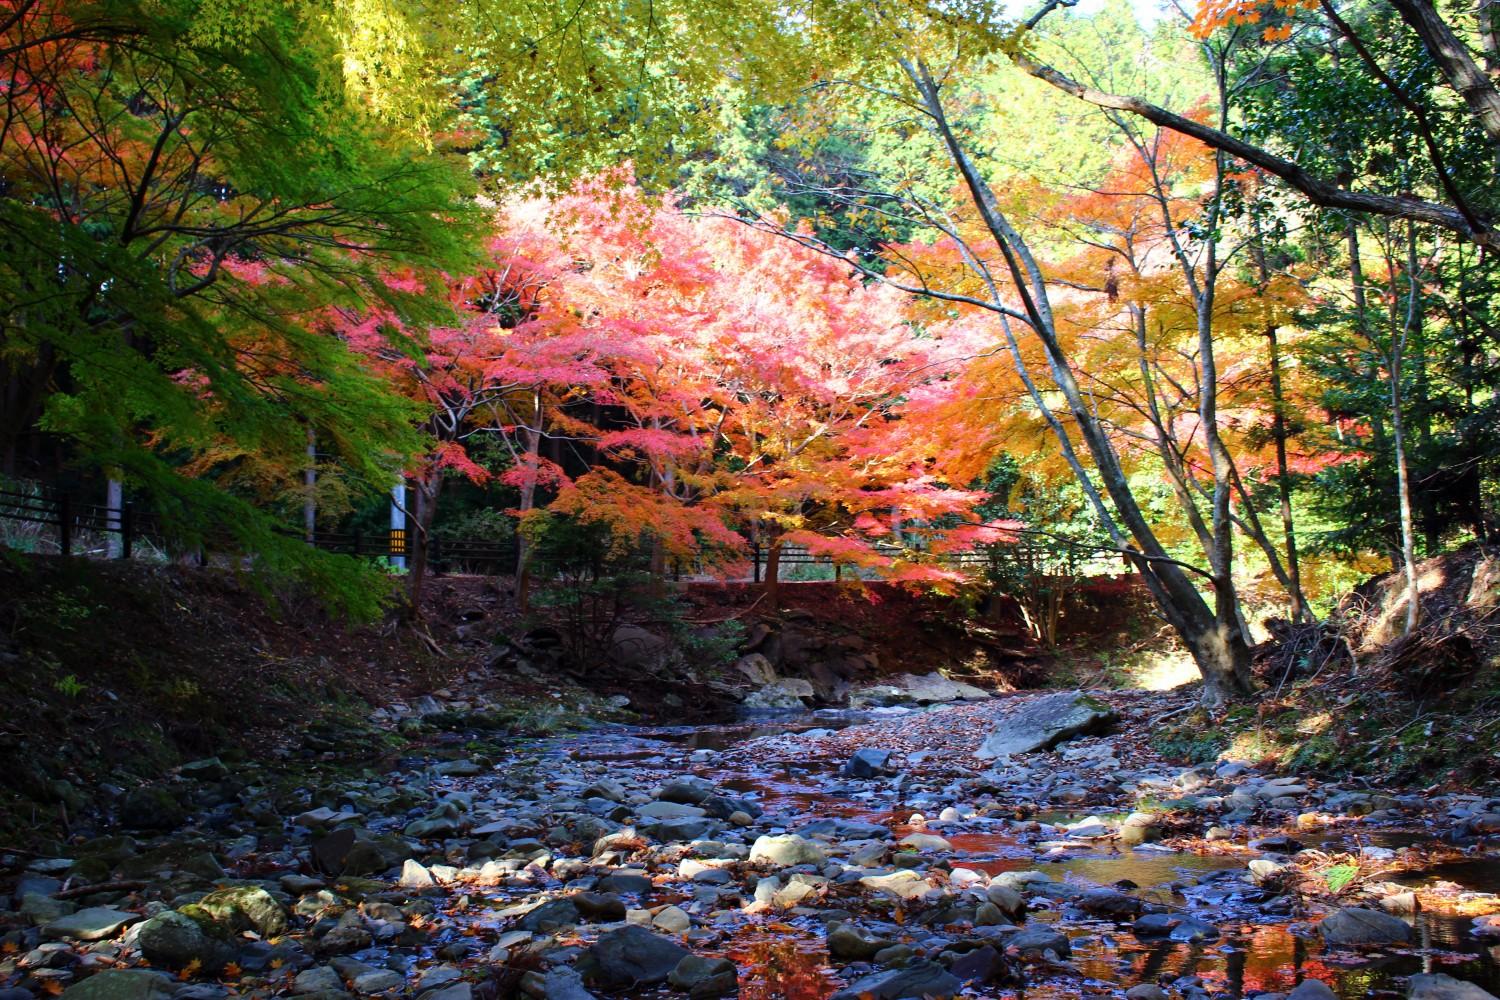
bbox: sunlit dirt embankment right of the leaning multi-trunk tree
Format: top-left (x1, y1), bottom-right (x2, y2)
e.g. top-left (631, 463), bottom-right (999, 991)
top-left (1158, 546), bottom-right (1500, 790)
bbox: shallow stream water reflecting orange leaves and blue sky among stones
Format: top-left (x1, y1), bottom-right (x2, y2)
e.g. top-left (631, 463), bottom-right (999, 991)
top-left (501, 714), bottom-right (1500, 1000)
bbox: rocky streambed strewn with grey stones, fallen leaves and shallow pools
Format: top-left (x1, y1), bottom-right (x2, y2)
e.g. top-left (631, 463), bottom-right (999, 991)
top-left (0, 693), bottom-right (1500, 1000)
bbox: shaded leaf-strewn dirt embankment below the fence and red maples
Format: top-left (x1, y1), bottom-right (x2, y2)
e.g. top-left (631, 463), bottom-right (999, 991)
top-left (0, 552), bottom-right (1158, 843)
